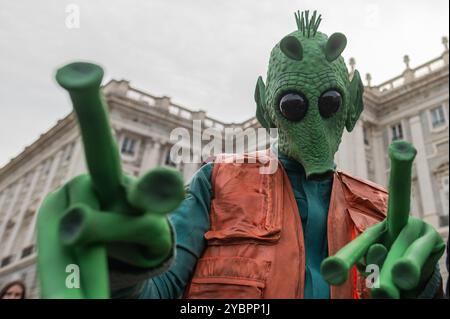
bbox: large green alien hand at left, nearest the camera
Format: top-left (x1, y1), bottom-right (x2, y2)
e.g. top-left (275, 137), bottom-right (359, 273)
top-left (37, 63), bottom-right (184, 298)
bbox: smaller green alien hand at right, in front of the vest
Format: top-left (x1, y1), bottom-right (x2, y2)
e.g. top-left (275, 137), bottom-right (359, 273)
top-left (321, 141), bottom-right (445, 298)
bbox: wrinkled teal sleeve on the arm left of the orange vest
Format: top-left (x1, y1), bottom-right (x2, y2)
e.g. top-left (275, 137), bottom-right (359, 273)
top-left (113, 163), bottom-right (213, 299)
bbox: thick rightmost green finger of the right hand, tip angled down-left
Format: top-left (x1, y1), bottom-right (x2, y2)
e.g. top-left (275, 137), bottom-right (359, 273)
top-left (392, 224), bottom-right (445, 290)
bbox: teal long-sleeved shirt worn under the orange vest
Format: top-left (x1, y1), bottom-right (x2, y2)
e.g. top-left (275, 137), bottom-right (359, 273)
top-left (139, 156), bottom-right (332, 299)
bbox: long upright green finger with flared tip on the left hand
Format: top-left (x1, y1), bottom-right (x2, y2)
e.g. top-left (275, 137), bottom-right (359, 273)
top-left (56, 62), bottom-right (122, 208)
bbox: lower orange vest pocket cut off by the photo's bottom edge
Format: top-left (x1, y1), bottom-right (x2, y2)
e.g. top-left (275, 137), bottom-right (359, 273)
top-left (186, 257), bottom-right (270, 299)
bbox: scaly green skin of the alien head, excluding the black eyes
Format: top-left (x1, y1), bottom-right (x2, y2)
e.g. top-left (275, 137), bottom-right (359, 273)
top-left (257, 31), bottom-right (363, 177)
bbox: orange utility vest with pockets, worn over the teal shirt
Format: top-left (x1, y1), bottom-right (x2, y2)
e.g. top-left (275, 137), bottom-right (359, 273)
top-left (184, 153), bottom-right (387, 299)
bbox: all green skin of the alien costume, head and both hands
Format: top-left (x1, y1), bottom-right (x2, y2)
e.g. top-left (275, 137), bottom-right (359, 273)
top-left (37, 10), bottom-right (445, 298)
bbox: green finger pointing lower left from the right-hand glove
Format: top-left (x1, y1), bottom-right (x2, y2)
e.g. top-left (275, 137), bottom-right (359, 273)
top-left (320, 221), bottom-right (386, 285)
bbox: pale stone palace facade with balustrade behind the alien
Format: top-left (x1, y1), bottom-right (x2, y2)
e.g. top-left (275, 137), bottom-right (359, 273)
top-left (0, 38), bottom-right (449, 297)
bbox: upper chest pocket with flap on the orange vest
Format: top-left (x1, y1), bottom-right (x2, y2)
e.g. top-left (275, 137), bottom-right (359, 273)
top-left (205, 166), bottom-right (283, 245)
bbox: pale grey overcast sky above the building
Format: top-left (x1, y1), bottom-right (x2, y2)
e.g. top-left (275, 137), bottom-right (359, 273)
top-left (0, 0), bottom-right (449, 167)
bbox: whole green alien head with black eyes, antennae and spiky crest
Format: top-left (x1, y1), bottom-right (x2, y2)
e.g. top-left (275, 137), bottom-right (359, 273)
top-left (255, 11), bottom-right (363, 178)
